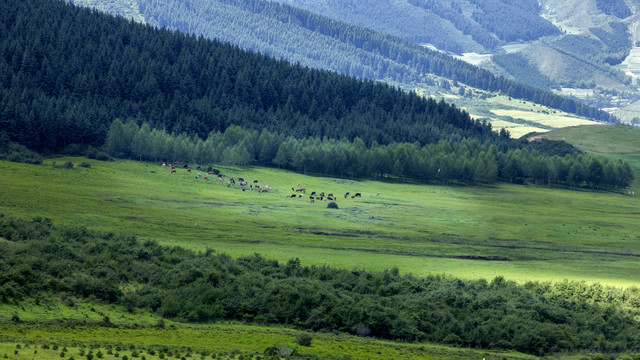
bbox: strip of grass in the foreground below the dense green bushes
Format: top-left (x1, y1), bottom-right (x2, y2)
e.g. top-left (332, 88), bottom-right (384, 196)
top-left (0, 302), bottom-right (534, 360)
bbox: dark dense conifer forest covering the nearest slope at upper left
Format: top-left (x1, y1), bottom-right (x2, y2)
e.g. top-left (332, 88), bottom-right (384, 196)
top-left (0, 0), bottom-right (508, 151)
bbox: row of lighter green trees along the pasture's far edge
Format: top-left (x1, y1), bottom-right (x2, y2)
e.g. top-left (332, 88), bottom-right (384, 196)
top-left (105, 119), bottom-right (634, 189)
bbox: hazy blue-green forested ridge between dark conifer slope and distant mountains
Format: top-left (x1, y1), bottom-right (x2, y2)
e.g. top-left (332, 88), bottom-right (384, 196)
top-left (76, 0), bottom-right (611, 126)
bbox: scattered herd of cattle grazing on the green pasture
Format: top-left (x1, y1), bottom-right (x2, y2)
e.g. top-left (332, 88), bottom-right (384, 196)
top-left (162, 161), bottom-right (380, 203)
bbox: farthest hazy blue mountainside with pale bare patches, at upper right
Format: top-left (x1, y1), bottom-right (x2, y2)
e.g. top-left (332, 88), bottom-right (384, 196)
top-left (270, 0), bottom-right (640, 120)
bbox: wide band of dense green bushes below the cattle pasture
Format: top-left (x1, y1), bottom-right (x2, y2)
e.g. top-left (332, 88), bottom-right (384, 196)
top-left (0, 214), bottom-right (640, 355)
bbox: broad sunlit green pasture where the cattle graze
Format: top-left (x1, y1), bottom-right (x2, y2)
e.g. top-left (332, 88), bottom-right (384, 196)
top-left (0, 152), bottom-right (640, 286)
